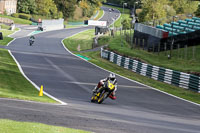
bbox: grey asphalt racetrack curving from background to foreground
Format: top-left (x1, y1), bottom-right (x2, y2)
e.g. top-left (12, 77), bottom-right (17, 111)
top-left (0, 8), bottom-right (200, 133)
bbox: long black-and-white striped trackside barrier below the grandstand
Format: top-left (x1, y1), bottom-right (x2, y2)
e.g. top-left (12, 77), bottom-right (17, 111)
top-left (101, 48), bottom-right (200, 93)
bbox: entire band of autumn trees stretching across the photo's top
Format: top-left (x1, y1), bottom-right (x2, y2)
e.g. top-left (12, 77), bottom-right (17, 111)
top-left (17, 0), bottom-right (200, 22)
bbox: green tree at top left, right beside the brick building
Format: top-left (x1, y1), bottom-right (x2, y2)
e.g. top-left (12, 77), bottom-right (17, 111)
top-left (17, 0), bottom-right (37, 14)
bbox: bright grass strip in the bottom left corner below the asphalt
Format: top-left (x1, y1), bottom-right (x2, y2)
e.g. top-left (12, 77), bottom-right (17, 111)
top-left (0, 119), bottom-right (89, 133)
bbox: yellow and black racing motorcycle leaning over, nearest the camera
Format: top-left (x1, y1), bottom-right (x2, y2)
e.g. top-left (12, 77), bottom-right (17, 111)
top-left (91, 80), bottom-right (115, 104)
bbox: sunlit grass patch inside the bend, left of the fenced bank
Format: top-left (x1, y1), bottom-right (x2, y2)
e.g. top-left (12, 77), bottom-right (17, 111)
top-left (64, 29), bottom-right (95, 51)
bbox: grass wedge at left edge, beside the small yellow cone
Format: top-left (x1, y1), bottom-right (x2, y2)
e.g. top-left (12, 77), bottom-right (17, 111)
top-left (0, 49), bottom-right (56, 103)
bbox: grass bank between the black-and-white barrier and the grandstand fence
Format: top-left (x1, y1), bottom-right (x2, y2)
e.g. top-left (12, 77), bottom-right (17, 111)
top-left (109, 36), bottom-right (200, 72)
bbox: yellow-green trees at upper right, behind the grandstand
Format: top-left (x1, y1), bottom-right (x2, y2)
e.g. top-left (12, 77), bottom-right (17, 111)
top-left (107, 0), bottom-right (200, 22)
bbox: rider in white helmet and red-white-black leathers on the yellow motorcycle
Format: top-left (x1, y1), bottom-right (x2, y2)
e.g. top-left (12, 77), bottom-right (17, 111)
top-left (93, 73), bottom-right (117, 100)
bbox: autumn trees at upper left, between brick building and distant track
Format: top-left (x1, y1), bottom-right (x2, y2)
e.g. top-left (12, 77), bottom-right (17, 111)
top-left (17, 0), bottom-right (105, 19)
